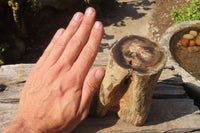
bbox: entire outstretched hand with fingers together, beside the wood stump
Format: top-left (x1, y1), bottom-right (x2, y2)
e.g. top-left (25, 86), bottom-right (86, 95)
top-left (4, 8), bottom-right (105, 133)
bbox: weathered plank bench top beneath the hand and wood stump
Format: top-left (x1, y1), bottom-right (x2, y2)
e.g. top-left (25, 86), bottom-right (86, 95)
top-left (0, 64), bottom-right (200, 133)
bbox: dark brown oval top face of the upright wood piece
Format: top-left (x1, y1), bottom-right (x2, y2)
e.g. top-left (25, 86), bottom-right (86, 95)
top-left (112, 35), bottom-right (166, 74)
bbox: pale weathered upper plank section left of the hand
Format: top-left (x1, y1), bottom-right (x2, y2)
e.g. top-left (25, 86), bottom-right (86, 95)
top-left (0, 64), bottom-right (34, 103)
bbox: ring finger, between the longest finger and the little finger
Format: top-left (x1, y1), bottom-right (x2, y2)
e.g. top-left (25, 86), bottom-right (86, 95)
top-left (45, 12), bottom-right (83, 66)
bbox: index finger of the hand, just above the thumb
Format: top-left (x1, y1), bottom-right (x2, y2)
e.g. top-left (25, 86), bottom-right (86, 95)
top-left (71, 22), bottom-right (103, 79)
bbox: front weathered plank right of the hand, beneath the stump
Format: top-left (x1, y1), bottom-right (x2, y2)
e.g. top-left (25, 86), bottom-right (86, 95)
top-left (74, 99), bottom-right (200, 133)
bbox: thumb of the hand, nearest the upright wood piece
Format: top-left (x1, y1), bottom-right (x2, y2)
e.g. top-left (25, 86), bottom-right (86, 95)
top-left (80, 67), bottom-right (105, 118)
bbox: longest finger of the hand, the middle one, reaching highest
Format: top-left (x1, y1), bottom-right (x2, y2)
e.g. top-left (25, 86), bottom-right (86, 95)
top-left (58, 8), bottom-right (96, 66)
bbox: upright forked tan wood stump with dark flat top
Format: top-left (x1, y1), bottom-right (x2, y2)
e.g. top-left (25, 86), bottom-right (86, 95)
top-left (97, 36), bottom-right (166, 126)
